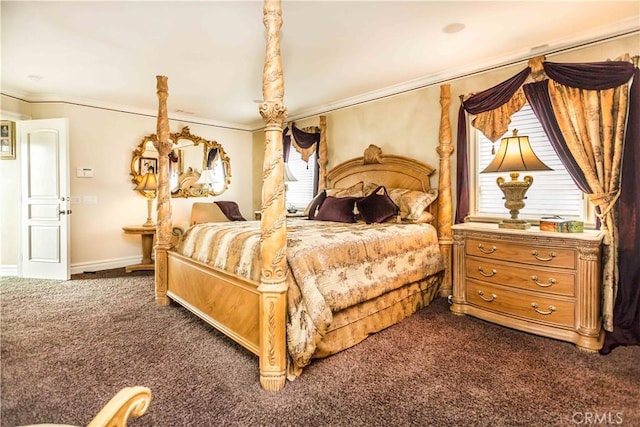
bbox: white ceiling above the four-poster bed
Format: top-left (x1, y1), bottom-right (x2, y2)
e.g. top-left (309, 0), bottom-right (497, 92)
top-left (0, 0), bottom-right (640, 129)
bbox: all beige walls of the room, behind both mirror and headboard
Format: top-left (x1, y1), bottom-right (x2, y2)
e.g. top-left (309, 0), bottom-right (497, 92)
top-left (0, 34), bottom-right (640, 271)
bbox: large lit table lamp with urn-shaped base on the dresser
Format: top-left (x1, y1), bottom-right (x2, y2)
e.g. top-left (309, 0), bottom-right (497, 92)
top-left (480, 129), bottom-right (552, 230)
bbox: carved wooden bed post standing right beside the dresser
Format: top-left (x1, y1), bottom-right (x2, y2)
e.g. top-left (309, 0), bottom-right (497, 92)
top-left (436, 84), bottom-right (454, 297)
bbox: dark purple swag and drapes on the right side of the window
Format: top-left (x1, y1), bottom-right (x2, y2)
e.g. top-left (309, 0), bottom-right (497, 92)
top-left (524, 61), bottom-right (640, 354)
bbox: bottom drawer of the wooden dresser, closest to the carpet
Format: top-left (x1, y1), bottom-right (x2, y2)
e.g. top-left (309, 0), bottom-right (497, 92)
top-left (466, 280), bottom-right (575, 328)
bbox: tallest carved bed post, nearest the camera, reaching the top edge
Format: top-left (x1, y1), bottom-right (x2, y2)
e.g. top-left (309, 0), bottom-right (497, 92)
top-left (258, 0), bottom-right (287, 391)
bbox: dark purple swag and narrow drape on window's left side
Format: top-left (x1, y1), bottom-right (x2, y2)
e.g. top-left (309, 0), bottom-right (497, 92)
top-left (455, 67), bottom-right (531, 224)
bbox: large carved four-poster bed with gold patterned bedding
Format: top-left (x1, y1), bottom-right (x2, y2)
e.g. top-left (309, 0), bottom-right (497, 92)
top-left (155, 0), bottom-right (453, 390)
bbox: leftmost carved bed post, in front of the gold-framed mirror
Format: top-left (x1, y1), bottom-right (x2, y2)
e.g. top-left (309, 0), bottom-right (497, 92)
top-left (154, 76), bottom-right (171, 305)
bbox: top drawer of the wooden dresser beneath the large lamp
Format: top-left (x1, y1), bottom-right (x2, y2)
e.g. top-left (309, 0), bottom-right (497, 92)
top-left (466, 239), bottom-right (576, 269)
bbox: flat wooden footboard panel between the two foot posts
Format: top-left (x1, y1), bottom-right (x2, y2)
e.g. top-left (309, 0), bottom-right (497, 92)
top-left (167, 252), bottom-right (260, 355)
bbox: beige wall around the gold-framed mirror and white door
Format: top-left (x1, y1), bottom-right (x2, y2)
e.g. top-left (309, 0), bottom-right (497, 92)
top-left (1, 97), bottom-right (253, 273)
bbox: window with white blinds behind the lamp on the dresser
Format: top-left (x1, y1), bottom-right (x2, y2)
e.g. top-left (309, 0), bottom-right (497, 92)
top-left (474, 104), bottom-right (587, 221)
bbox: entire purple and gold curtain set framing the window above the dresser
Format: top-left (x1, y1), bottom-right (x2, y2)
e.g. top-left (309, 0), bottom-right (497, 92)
top-left (455, 55), bottom-right (640, 354)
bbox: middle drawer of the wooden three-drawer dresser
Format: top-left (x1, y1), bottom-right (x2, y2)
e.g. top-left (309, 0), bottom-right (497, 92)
top-left (466, 257), bottom-right (575, 296)
